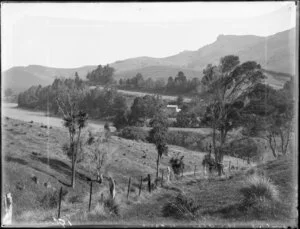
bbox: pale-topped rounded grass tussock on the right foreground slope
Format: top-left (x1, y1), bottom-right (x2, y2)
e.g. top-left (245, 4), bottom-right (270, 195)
top-left (240, 174), bottom-right (279, 206)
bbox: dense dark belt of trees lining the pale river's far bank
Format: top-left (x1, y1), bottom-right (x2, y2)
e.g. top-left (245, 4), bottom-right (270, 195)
top-left (18, 72), bottom-right (127, 119)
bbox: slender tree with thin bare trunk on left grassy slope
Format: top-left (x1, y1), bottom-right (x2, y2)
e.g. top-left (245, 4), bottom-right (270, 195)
top-left (56, 97), bottom-right (88, 189)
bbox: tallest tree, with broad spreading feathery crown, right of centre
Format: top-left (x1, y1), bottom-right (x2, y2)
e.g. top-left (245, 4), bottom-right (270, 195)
top-left (201, 55), bottom-right (265, 175)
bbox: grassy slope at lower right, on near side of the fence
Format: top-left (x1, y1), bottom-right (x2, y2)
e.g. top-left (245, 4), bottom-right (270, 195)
top-left (123, 153), bottom-right (297, 226)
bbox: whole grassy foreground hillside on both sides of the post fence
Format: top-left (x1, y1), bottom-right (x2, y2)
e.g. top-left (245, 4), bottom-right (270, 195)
top-left (2, 118), bottom-right (295, 225)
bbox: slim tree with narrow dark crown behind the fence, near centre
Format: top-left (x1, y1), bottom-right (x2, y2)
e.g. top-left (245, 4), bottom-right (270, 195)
top-left (149, 109), bottom-right (168, 180)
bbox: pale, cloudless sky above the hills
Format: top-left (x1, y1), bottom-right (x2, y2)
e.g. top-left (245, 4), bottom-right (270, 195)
top-left (1, 2), bottom-right (296, 70)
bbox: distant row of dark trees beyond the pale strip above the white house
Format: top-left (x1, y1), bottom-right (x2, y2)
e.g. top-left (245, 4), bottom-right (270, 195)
top-left (118, 71), bottom-right (200, 95)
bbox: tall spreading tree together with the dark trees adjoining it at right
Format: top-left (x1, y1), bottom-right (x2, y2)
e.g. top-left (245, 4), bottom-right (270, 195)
top-left (201, 55), bottom-right (293, 174)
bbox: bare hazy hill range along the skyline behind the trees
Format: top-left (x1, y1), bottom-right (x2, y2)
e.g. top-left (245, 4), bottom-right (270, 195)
top-left (2, 28), bottom-right (296, 90)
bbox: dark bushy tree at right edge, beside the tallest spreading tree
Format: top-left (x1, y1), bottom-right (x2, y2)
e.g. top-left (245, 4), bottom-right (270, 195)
top-left (244, 84), bottom-right (293, 158)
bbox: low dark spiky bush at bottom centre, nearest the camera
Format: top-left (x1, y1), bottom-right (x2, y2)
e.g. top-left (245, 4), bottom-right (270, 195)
top-left (162, 193), bottom-right (200, 219)
